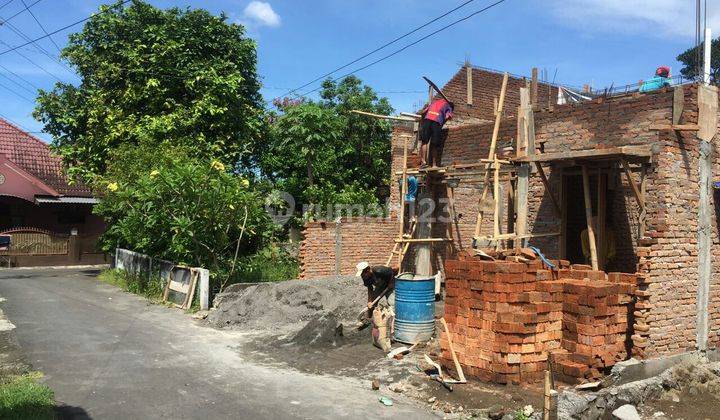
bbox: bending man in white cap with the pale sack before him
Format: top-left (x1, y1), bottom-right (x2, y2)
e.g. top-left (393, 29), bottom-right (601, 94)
top-left (356, 261), bottom-right (395, 352)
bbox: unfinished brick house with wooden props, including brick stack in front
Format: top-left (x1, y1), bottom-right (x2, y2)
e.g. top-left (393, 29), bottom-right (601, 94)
top-left (301, 68), bottom-right (720, 382)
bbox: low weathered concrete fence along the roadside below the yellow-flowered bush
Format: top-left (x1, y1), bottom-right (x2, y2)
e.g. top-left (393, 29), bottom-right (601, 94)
top-left (113, 248), bottom-right (210, 311)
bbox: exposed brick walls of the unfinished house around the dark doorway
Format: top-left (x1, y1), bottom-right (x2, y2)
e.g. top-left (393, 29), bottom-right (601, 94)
top-left (393, 84), bottom-right (720, 358)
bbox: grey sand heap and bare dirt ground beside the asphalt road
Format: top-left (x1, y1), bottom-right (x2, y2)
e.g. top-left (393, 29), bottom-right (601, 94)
top-left (208, 277), bottom-right (542, 418)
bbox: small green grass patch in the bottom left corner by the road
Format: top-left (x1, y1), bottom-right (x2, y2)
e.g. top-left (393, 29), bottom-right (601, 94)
top-left (0, 372), bottom-right (55, 420)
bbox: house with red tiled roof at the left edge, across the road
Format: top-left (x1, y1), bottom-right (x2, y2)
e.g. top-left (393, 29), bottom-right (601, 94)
top-left (0, 119), bottom-right (105, 266)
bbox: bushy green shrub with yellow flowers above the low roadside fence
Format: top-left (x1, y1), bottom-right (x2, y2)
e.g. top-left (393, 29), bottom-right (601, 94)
top-left (95, 146), bottom-right (275, 281)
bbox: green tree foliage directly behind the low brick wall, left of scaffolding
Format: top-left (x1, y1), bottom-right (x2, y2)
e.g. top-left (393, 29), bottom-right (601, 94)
top-left (260, 76), bottom-right (393, 212)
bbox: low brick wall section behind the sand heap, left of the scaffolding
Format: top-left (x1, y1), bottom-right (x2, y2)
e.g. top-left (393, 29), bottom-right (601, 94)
top-left (300, 218), bottom-right (398, 279)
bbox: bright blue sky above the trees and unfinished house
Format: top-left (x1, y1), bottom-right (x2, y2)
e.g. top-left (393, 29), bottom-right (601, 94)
top-left (0, 0), bottom-right (720, 140)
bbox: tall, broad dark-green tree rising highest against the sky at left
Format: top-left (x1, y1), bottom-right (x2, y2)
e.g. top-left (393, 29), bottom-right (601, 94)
top-left (35, 0), bottom-right (263, 180)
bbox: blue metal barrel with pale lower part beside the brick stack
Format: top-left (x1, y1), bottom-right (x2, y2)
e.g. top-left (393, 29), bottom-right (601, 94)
top-left (395, 274), bottom-right (435, 344)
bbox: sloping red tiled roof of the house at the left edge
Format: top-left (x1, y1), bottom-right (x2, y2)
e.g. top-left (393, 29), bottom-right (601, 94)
top-left (0, 118), bottom-right (92, 197)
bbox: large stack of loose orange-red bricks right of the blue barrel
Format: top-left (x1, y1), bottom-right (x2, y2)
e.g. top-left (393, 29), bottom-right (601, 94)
top-left (440, 259), bottom-right (632, 383)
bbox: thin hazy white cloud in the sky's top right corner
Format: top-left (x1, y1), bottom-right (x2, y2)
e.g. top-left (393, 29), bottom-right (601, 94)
top-left (550, 0), bottom-right (720, 38)
